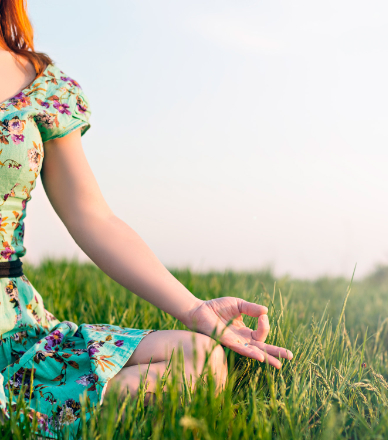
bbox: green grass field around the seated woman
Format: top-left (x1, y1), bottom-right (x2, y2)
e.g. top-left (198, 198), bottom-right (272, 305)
top-left (0, 261), bottom-right (388, 440)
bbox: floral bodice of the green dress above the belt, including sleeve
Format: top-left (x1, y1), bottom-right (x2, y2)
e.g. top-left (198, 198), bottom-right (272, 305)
top-left (0, 64), bottom-right (90, 261)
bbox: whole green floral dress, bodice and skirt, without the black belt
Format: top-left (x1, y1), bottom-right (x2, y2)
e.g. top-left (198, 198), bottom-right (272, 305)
top-left (0, 64), bottom-right (152, 437)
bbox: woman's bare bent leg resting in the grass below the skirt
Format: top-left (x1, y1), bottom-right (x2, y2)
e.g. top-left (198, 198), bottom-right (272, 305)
top-left (106, 330), bottom-right (228, 403)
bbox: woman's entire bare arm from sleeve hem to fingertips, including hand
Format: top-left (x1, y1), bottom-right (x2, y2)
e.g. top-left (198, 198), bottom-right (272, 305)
top-left (41, 130), bottom-right (292, 368)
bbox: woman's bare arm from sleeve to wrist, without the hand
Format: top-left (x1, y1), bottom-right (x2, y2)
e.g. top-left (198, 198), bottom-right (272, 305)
top-left (41, 130), bottom-right (201, 324)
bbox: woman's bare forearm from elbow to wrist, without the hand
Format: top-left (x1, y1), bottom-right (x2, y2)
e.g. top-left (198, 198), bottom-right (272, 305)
top-left (69, 215), bottom-right (201, 325)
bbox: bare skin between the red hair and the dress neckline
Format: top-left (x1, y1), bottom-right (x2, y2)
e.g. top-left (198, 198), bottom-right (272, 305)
top-left (0, 49), bottom-right (36, 103)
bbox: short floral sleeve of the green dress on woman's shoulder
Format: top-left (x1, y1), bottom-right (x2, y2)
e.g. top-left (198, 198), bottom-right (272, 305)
top-left (35, 83), bottom-right (91, 142)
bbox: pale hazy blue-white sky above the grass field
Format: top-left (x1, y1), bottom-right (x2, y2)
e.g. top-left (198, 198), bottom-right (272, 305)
top-left (25, 0), bottom-right (388, 278)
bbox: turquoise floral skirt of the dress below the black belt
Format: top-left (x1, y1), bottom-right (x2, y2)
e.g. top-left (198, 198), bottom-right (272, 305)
top-left (0, 275), bottom-right (153, 437)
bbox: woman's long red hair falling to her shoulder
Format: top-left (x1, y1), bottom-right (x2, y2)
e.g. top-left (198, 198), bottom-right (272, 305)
top-left (0, 0), bottom-right (53, 77)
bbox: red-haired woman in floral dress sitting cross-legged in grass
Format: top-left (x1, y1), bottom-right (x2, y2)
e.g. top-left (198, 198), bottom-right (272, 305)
top-left (0, 0), bottom-right (292, 434)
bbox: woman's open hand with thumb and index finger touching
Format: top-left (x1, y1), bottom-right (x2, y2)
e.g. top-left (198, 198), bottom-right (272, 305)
top-left (184, 297), bottom-right (293, 368)
